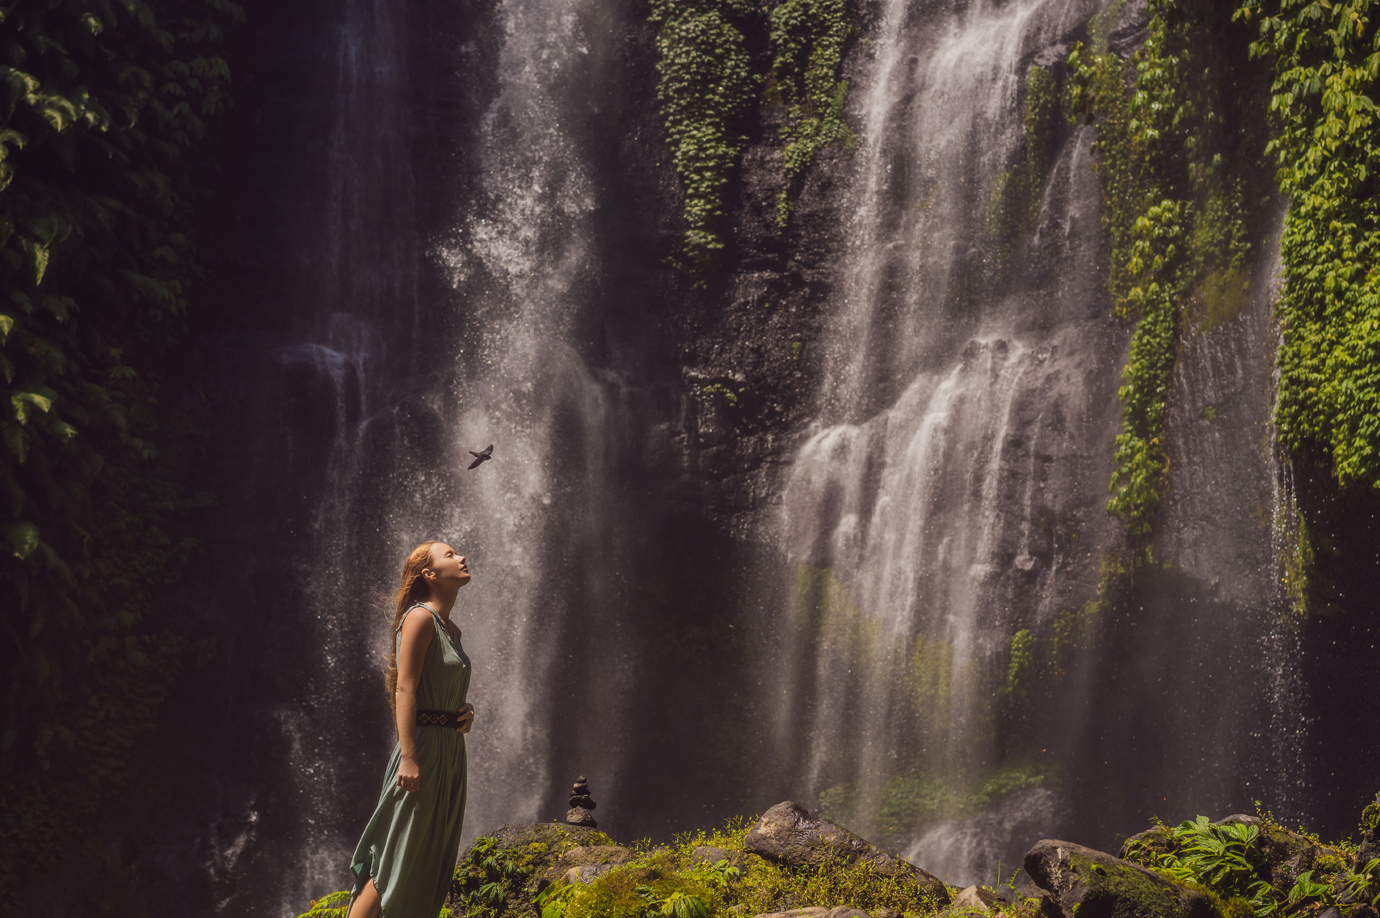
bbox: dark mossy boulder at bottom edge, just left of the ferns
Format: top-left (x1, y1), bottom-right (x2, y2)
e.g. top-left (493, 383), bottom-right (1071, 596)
top-left (1025, 838), bottom-right (1220, 918)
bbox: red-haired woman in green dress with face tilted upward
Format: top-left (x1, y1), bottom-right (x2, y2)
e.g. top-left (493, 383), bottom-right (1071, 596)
top-left (349, 543), bottom-right (475, 918)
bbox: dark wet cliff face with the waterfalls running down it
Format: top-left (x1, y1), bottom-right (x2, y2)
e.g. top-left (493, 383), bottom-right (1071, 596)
top-left (62, 0), bottom-right (1368, 914)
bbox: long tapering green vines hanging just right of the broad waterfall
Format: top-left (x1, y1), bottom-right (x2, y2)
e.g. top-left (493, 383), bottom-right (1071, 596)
top-left (1065, 0), bottom-right (1260, 540)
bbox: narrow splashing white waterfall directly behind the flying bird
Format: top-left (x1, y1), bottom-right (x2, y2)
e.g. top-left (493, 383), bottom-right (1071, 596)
top-left (437, 0), bottom-right (625, 838)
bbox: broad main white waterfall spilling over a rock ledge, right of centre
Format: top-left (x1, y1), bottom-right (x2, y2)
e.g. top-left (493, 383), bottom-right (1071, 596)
top-left (781, 1), bottom-right (1105, 861)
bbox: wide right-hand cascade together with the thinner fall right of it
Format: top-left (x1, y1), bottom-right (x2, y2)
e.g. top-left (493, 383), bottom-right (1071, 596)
top-left (776, 0), bottom-right (1297, 882)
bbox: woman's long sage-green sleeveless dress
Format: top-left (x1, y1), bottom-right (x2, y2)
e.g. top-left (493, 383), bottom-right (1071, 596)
top-left (351, 603), bottom-right (469, 918)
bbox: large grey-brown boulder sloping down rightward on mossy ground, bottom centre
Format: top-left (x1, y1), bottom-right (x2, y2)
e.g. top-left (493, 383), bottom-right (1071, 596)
top-left (742, 801), bottom-right (949, 906)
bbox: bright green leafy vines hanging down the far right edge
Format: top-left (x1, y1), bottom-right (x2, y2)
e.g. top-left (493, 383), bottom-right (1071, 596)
top-left (1238, 0), bottom-right (1380, 489)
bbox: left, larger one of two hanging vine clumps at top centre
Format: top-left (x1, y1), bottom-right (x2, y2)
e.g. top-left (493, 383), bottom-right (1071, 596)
top-left (651, 0), bottom-right (755, 269)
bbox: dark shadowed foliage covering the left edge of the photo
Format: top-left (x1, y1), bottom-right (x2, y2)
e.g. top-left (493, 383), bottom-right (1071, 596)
top-left (0, 0), bottom-right (242, 907)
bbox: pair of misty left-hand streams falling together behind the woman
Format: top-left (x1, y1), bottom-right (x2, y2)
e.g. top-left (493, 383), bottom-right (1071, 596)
top-left (218, 0), bottom-right (629, 915)
